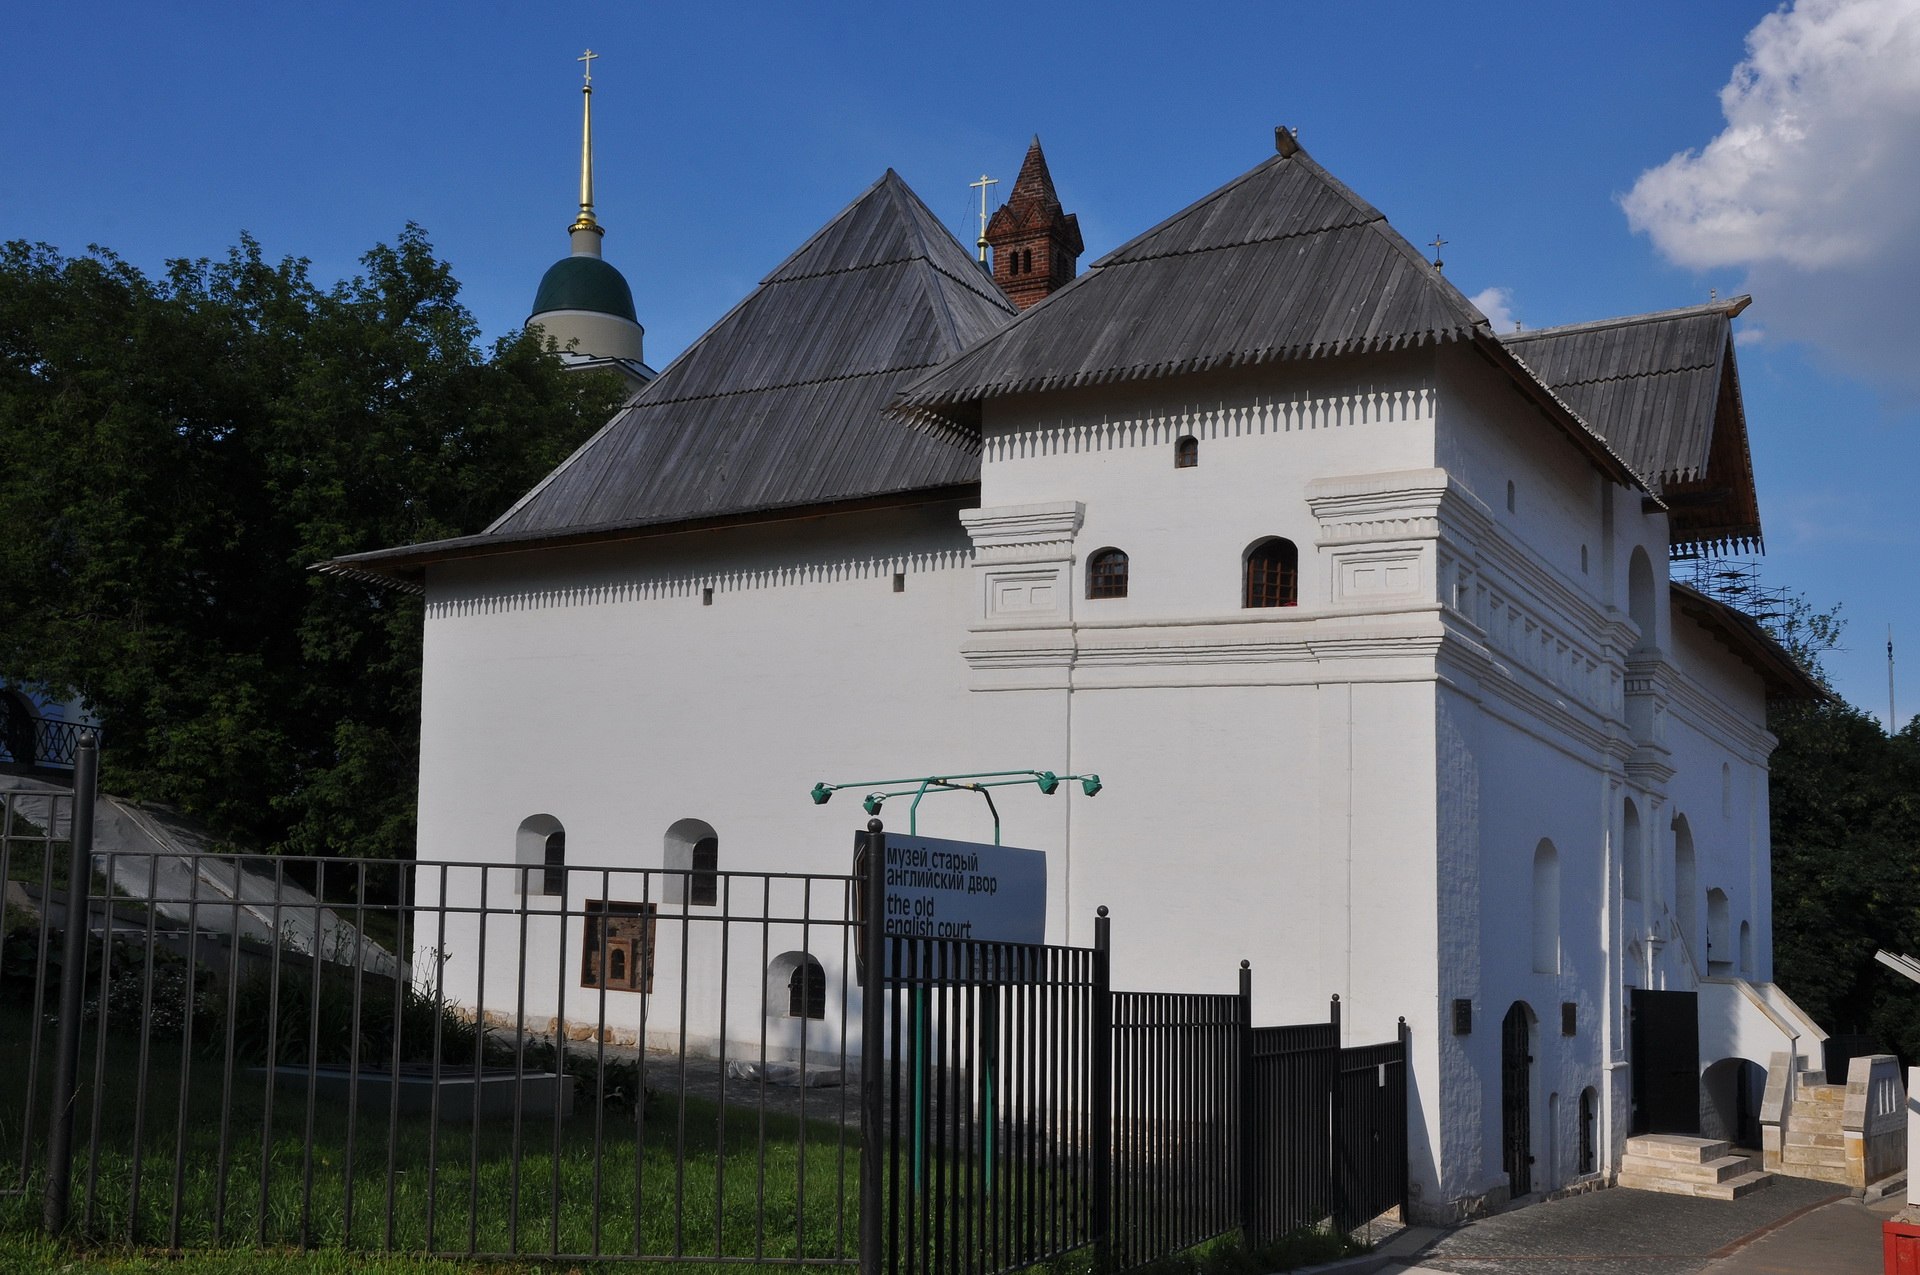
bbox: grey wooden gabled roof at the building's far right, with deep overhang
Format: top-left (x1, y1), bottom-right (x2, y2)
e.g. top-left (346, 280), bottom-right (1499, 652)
top-left (1501, 296), bottom-right (1761, 553)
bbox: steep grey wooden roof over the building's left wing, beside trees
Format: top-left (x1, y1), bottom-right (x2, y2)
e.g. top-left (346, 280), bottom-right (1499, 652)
top-left (330, 169), bottom-right (1014, 576)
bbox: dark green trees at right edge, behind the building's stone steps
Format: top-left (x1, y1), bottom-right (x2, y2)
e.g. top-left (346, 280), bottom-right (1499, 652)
top-left (1768, 599), bottom-right (1920, 1060)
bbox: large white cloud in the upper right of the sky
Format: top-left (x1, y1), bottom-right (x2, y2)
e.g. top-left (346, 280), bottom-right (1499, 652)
top-left (1622, 0), bottom-right (1920, 401)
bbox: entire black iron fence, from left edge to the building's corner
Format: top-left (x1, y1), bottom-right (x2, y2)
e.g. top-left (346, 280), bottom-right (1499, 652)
top-left (0, 749), bottom-right (1407, 1275)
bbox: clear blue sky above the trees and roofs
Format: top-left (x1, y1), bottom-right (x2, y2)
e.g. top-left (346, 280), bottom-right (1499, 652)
top-left (0, 0), bottom-right (1920, 720)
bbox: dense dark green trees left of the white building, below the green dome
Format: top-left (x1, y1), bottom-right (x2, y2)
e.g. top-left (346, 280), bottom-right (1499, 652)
top-left (0, 235), bottom-right (620, 856)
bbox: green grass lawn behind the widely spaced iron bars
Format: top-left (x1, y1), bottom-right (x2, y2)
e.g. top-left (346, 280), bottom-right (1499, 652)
top-left (0, 1008), bottom-right (858, 1271)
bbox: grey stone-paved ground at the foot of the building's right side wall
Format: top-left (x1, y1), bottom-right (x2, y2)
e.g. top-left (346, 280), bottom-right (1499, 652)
top-left (1407, 1177), bottom-right (1878, 1275)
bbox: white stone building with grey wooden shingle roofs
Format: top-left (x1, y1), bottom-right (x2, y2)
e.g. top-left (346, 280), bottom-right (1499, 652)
top-left (330, 134), bottom-right (1818, 1214)
